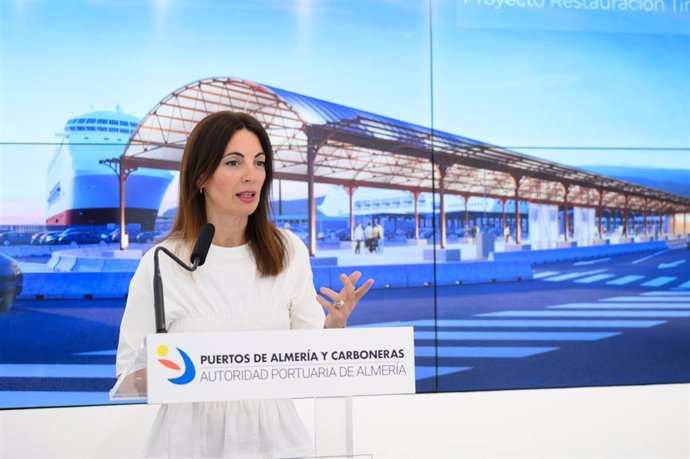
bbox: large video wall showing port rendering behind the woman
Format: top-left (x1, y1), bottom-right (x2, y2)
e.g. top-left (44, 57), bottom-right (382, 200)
top-left (0, 0), bottom-right (690, 409)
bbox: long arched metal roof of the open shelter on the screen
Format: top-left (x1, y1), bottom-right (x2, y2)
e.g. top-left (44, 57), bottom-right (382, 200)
top-left (117, 77), bottom-right (690, 252)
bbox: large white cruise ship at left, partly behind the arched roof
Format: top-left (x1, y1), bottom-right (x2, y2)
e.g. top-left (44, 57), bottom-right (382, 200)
top-left (46, 107), bottom-right (173, 230)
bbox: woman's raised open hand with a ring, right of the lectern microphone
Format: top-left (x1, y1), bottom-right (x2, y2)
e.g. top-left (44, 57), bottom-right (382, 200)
top-left (316, 271), bottom-right (374, 328)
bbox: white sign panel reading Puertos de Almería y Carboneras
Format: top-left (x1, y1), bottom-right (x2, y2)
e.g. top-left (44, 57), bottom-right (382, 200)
top-left (147, 327), bottom-right (415, 403)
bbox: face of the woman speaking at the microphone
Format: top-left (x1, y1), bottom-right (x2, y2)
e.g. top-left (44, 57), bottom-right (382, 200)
top-left (203, 129), bottom-right (266, 221)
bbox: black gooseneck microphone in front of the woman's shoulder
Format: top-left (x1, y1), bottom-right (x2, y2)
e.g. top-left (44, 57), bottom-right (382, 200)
top-left (153, 223), bottom-right (216, 333)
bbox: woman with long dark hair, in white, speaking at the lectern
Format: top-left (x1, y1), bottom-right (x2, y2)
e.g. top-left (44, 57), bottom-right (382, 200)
top-left (116, 111), bottom-right (373, 458)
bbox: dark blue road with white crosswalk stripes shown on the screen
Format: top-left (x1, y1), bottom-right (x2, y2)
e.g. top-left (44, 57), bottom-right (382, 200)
top-left (0, 249), bottom-right (690, 408)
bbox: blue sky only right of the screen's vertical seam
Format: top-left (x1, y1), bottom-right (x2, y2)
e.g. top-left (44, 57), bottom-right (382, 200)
top-left (432, 0), bottom-right (690, 164)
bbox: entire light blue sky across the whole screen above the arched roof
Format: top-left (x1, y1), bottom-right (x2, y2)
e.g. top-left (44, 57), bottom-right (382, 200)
top-left (0, 0), bottom-right (690, 222)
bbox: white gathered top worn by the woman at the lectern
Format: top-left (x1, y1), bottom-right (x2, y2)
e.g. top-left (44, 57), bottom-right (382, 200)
top-left (117, 230), bottom-right (325, 457)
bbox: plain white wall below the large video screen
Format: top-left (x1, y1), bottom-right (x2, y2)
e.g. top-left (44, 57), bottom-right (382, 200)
top-left (0, 384), bottom-right (690, 459)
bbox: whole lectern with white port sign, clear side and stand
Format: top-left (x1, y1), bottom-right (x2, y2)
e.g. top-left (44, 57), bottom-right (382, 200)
top-left (110, 327), bottom-right (415, 458)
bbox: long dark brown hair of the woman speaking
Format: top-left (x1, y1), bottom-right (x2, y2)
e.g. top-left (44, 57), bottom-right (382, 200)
top-left (171, 111), bottom-right (286, 276)
